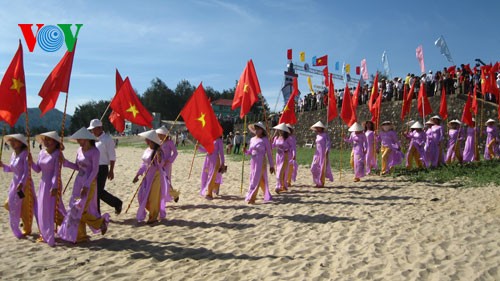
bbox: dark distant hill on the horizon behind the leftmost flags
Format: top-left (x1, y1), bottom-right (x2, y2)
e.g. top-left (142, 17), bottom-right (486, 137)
top-left (2, 108), bottom-right (71, 131)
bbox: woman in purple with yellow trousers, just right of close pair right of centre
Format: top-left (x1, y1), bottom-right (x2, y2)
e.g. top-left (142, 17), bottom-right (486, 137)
top-left (378, 121), bottom-right (403, 176)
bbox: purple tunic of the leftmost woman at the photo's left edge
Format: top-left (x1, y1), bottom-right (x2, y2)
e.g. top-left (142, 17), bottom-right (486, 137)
top-left (3, 150), bottom-right (38, 238)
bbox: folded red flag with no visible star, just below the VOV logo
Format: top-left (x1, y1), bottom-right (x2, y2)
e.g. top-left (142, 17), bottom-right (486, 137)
top-left (38, 40), bottom-right (76, 116)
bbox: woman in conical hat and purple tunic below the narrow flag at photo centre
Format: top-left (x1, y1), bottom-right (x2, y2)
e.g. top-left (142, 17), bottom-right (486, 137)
top-left (245, 122), bottom-right (274, 204)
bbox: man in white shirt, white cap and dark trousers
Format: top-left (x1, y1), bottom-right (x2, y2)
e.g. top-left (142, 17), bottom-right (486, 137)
top-left (88, 119), bottom-right (123, 212)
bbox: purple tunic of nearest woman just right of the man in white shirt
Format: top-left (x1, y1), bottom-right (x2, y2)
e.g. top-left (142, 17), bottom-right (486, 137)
top-left (136, 147), bottom-right (171, 222)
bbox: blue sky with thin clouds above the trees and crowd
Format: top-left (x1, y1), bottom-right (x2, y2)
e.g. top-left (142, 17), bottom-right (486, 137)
top-left (0, 0), bottom-right (500, 113)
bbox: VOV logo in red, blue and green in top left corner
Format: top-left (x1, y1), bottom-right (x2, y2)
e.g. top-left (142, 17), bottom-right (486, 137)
top-left (18, 23), bottom-right (83, 52)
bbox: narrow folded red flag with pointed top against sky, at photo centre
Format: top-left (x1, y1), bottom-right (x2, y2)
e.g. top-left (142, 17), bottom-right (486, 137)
top-left (231, 60), bottom-right (261, 119)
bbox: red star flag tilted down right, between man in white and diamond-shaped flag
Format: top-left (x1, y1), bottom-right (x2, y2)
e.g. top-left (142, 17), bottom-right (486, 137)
top-left (110, 77), bottom-right (153, 128)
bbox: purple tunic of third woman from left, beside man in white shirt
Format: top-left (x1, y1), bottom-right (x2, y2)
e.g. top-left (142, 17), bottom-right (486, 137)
top-left (57, 147), bottom-right (109, 243)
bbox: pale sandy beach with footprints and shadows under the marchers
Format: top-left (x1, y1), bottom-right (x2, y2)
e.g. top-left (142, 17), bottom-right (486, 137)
top-left (0, 143), bottom-right (500, 280)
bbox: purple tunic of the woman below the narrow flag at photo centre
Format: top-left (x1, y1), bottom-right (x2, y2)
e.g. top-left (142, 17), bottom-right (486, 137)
top-left (245, 136), bottom-right (274, 202)
